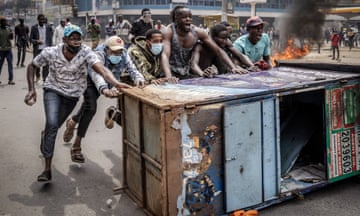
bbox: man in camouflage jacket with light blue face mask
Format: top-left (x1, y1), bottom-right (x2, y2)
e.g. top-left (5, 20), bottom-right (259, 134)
top-left (129, 29), bottom-right (169, 83)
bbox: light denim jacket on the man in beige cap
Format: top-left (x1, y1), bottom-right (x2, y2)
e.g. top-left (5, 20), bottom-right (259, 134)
top-left (88, 44), bottom-right (145, 93)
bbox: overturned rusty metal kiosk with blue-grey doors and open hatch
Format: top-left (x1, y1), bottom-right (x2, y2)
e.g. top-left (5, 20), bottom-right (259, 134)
top-left (120, 66), bottom-right (360, 215)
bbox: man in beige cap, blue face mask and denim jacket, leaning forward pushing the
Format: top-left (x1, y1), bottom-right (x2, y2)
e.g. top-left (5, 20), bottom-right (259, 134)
top-left (63, 36), bottom-right (145, 163)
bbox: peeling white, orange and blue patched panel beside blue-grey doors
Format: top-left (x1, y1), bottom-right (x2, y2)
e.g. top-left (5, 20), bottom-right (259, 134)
top-left (169, 104), bottom-right (223, 215)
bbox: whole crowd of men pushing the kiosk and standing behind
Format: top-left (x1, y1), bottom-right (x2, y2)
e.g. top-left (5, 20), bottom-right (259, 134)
top-left (0, 5), bottom-right (358, 181)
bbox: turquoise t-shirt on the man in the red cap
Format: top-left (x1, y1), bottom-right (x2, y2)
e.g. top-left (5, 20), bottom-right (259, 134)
top-left (233, 33), bottom-right (270, 63)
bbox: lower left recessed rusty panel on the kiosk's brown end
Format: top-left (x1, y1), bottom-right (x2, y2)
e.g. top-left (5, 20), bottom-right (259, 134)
top-left (126, 145), bottom-right (143, 205)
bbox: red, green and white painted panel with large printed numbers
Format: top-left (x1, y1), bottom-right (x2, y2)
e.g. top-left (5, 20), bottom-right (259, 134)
top-left (326, 84), bottom-right (360, 181)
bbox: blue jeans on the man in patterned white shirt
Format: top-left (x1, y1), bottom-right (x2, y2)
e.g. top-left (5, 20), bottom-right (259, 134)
top-left (40, 89), bottom-right (78, 158)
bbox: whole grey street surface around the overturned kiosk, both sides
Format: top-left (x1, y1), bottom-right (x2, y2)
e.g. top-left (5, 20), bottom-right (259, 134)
top-left (0, 43), bottom-right (360, 216)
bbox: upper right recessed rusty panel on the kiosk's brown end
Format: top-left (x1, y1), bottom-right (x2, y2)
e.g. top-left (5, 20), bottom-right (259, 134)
top-left (142, 104), bottom-right (164, 163)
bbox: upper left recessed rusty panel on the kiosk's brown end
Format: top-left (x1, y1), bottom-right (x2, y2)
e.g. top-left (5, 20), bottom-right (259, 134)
top-left (123, 96), bottom-right (140, 149)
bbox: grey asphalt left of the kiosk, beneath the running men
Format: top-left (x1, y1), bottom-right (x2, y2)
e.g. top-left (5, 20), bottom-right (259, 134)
top-left (0, 44), bottom-right (145, 216)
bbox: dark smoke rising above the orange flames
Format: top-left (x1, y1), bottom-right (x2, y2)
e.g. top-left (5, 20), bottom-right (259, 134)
top-left (275, 0), bottom-right (338, 50)
